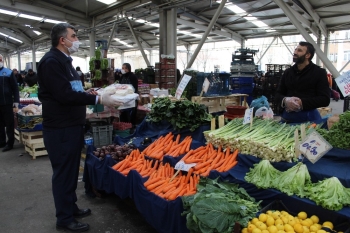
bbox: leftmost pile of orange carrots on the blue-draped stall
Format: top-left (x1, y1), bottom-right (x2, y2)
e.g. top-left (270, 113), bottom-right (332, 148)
top-left (112, 149), bottom-right (159, 177)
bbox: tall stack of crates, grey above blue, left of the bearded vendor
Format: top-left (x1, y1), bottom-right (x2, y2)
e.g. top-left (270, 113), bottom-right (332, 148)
top-left (230, 48), bottom-right (258, 104)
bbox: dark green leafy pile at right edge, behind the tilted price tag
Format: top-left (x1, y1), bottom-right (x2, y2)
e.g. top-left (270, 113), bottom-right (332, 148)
top-left (316, 111), bottom-right (350, 149)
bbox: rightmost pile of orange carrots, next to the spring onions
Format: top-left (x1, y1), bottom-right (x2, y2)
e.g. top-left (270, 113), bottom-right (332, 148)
top-left (181, 143), bottom-right (238, 176)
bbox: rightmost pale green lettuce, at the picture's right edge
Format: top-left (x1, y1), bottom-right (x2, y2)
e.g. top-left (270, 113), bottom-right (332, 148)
top-left (305, 177), bottom-right (350, 211)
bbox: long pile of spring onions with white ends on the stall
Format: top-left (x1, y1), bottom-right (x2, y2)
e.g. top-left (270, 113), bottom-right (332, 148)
top-left (204, 118), bottom-right (313, 162)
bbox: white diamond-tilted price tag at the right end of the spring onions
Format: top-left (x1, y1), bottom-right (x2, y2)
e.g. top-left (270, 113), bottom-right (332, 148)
top-left (299, 131), bottom-right (333, 163)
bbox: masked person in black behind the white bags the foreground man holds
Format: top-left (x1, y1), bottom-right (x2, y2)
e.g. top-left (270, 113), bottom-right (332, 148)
top-left (119, 63), bottom-right (138, 126)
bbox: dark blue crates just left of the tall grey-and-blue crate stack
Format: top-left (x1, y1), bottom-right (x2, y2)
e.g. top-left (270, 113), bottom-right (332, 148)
top-left (196, 72), bottom-right (231, 97)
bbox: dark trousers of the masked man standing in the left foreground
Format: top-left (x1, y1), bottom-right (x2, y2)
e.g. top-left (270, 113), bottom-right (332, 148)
top-left (43, 126), bottom-right (84, 225)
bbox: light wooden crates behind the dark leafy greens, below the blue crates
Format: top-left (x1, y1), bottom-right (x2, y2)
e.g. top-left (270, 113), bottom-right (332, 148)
top-left (191, 94), bottom-right (248, 113)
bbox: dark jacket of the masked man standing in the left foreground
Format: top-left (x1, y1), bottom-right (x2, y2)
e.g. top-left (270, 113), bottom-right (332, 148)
top-left (38, 48), bottom-right (96, 128)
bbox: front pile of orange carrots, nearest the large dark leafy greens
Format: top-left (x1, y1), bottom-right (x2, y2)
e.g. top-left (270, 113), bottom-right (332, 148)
top-left (144, 163), bottom-right (200, 201)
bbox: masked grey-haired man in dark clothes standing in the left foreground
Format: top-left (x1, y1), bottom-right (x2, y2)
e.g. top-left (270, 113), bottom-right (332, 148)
top-left (38, 23), bottom-right (121, 232)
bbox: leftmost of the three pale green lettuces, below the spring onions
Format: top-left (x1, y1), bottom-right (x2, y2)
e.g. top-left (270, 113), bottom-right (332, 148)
top-left (244, 159), bottom-right (281, 189)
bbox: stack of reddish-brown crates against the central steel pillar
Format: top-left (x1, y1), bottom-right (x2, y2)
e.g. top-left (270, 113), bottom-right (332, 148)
top-left (155, 58), bottom-right (176, 89)
